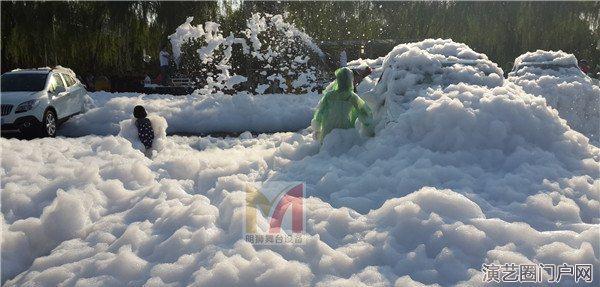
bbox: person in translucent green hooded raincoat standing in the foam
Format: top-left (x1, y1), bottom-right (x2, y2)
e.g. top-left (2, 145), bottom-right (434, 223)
top-left (312, 68), bottom-right (373, 142)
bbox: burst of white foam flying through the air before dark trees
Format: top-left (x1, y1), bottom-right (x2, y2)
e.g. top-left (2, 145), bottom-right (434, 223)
top-left (169, 13), bottom-right (323, 94)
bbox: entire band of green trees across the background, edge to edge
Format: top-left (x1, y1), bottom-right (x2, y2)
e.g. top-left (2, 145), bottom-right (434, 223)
top-left (0, 1), bottom-right (600, 80)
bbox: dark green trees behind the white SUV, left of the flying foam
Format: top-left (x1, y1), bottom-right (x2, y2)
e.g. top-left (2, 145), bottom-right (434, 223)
top-left (0, 1), bottom-right (217, 75)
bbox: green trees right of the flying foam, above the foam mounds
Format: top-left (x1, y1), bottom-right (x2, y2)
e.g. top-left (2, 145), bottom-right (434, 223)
top-left (282, 1), bottom-right (600, 74)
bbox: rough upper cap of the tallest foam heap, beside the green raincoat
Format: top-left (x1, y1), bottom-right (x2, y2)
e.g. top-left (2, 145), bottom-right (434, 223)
top-left (361, 39), bottom-right (504, 124)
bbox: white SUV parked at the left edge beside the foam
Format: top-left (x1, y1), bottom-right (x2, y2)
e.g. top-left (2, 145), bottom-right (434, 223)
top-left (0, 66), bottom-right (87, 137)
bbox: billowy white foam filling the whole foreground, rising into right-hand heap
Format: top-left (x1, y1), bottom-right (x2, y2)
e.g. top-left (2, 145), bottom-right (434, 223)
top-left (0, 40), bottom-right (600, 286)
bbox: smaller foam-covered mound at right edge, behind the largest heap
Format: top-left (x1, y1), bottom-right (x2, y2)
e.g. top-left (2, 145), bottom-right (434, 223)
top-left (508, 50), bottom-right (600, 145)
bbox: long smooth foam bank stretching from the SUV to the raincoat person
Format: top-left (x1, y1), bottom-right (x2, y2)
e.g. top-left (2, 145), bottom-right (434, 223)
top-left (59, 92), bottom-right (320, 137)
